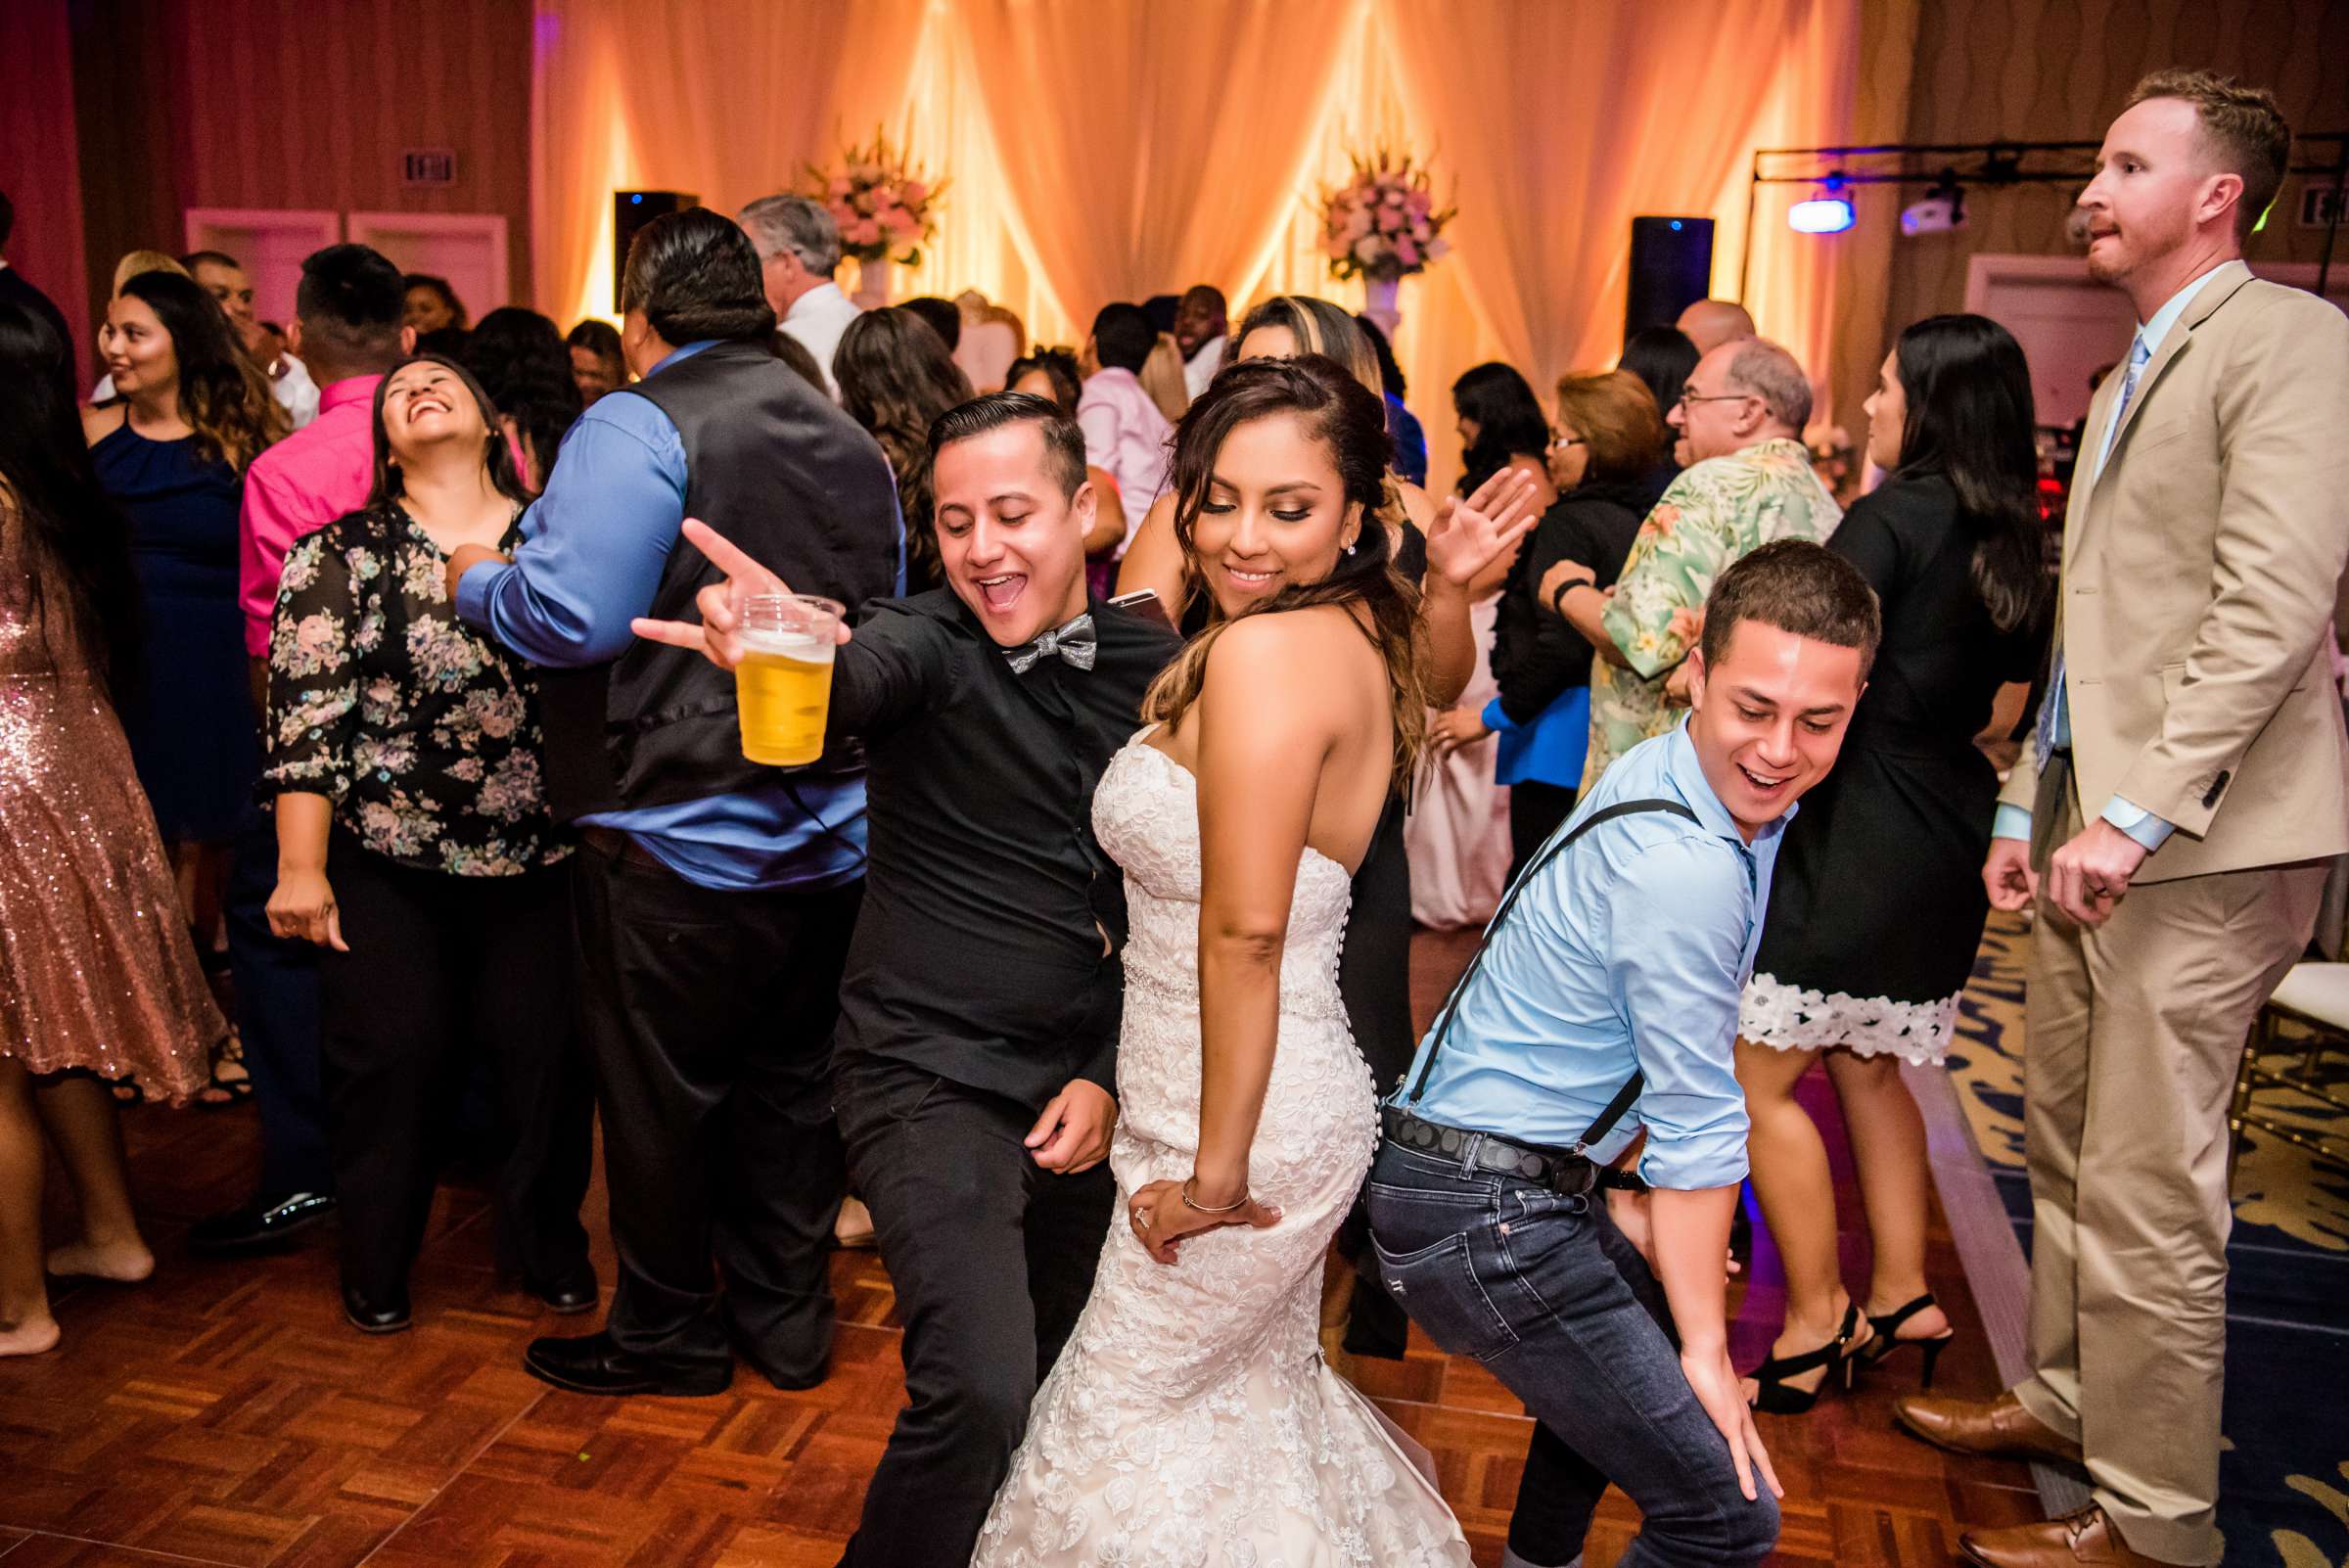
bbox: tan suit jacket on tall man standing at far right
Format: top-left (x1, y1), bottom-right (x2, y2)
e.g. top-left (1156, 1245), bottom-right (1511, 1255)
top-left (1999, 260), bottom-right (2349, 883)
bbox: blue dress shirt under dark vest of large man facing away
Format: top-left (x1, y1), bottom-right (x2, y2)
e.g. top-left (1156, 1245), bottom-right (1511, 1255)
top-left (456, 341), bottom-right (904, 892)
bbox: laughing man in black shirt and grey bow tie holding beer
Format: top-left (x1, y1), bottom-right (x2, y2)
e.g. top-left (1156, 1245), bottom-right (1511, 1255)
top-left (639, 392), bottom-right (1176, 1568)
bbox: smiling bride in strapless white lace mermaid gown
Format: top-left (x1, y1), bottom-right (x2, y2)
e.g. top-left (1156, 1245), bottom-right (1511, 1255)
top-left (975, 357), bottom-right (1532, 1568)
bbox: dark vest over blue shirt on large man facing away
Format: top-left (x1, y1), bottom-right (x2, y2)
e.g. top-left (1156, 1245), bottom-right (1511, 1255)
top-left (540, 343), bottom-right (898, 821)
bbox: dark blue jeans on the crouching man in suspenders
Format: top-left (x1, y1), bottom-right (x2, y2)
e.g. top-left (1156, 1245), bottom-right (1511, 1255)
top-left (1369, 1143), bottom-right (1778, 1568)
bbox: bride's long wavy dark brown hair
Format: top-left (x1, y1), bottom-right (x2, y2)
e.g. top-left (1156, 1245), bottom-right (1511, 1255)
top-left (1141, 354), bottom-right (1428, 791)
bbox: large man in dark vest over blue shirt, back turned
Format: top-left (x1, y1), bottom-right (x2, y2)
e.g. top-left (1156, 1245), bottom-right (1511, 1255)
top-left (448, 208), bottom-right (902, 1395)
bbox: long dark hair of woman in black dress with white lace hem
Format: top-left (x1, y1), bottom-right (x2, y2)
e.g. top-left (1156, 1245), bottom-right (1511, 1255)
top-left (1893, 314), bottom-right (2049, 631)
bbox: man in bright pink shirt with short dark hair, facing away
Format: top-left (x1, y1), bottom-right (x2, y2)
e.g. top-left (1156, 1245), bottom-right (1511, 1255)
top-left (188, 244), bottom-right (416, 1256)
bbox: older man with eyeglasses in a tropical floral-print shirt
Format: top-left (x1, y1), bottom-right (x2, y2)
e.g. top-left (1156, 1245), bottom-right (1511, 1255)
top-left (1541, 338), bottom-right (1844, 794)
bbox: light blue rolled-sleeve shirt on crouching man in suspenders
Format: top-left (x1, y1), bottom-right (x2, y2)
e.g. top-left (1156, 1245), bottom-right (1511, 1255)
top-left (1388, 723), bottom-right (1795, 1190)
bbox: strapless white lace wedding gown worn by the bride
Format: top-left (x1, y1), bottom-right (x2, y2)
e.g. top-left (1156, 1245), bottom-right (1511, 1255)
top-left (975, 732), bottom-right (1468, 1568)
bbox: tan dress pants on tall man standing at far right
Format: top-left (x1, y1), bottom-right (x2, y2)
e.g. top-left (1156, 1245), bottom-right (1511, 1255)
top-left (2015, 759), bottom-right (2326, 1563)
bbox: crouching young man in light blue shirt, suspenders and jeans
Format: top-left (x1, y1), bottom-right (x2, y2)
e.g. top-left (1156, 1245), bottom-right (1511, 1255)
top-left (1369, 540), bottom-right (1879, 1568)
